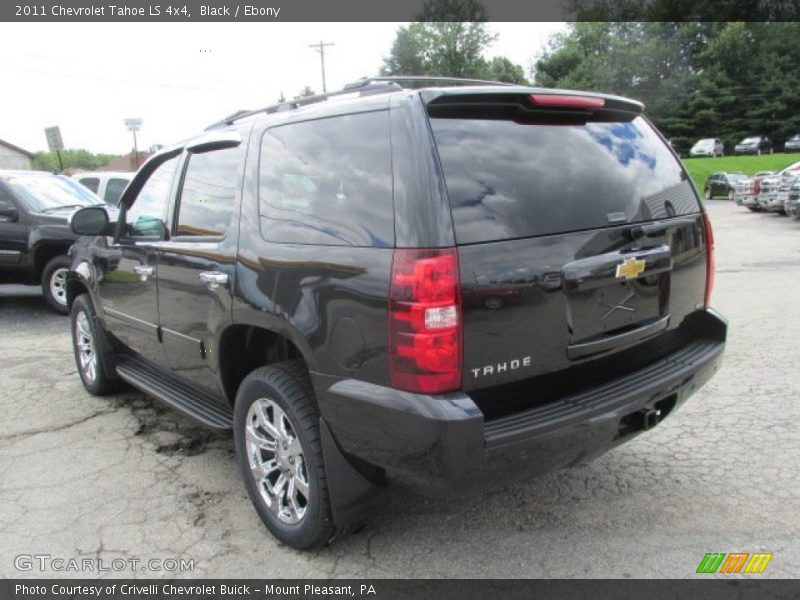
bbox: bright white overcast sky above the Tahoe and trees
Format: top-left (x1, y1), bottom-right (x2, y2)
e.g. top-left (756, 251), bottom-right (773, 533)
top-left (0, 23), bottom-right (565, 153)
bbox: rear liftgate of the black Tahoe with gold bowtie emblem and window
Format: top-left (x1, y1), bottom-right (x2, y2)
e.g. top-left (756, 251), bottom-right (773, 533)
top-left (427, 93), bottom-right (706, 390)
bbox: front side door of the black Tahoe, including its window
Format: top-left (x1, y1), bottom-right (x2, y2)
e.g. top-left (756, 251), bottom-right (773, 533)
top-left (98, 158), bottom-right (177, 363)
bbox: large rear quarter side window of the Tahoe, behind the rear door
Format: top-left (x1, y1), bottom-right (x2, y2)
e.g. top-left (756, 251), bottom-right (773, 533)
top-left (259, 111), bottom-right (394, 247)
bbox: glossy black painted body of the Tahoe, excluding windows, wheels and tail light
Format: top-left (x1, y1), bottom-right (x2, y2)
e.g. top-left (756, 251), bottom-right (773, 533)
top-left (70, 88), bottom-right (726, 488)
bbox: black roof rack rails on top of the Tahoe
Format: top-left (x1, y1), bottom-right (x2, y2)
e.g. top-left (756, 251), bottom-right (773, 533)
top-left (206, 75), bottom-right (513, 131)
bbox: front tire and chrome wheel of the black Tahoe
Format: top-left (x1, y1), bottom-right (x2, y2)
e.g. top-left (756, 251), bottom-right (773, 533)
top-left (70, 294), bottom-right (122, 396)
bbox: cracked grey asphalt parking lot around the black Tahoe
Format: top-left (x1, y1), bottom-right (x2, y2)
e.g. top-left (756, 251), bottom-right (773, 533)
top-left (0, 201), bottom-right (800, 578)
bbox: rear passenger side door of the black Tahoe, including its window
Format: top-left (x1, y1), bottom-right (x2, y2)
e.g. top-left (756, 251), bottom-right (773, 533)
top-left (158, 142), bottom-right (244, 393)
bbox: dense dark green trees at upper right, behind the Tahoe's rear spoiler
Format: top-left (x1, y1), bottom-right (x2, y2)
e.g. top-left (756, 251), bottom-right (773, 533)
top-left (535, 22), bottom-right (800, 150)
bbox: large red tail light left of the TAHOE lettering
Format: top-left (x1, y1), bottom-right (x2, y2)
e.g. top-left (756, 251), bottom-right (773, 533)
top-left (389, 248), bottom-right (462, 394)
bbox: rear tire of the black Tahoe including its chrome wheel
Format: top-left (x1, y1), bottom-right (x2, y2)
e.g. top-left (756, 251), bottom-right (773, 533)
top-left (233, 360), bottom-right (335, 550)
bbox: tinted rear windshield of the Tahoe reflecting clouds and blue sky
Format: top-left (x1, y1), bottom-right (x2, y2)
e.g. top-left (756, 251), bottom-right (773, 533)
top-left (431, 117), bottom-right (700, 244)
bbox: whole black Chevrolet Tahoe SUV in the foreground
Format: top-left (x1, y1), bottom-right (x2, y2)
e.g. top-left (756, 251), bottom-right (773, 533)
top-left (67, 78), bottom-right (727, 548)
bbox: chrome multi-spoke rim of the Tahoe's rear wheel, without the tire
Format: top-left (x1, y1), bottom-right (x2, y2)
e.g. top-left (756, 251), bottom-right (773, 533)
top-left (245, 398), bottom-right (311, 525)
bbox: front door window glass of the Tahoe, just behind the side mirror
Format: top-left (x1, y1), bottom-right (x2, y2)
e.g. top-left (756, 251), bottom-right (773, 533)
top-left (124, 157), bottom-right (178, 238)
